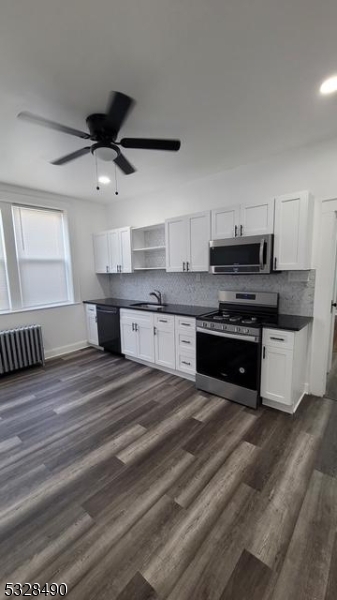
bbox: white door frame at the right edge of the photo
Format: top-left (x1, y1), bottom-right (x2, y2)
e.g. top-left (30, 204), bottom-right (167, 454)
top-left (309, 198), bottom-right (337, 396)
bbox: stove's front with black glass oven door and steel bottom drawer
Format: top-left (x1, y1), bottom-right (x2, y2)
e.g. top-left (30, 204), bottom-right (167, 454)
top-left (196, 327), bottom-right (261, 408)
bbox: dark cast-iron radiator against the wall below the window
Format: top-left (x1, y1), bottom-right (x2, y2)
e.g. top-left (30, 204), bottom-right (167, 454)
top-left (0, 325), bottom-right (44, 375)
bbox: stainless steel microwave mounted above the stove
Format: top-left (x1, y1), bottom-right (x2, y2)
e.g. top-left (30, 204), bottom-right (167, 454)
top-left (209, 234), bottom-right (274, 275)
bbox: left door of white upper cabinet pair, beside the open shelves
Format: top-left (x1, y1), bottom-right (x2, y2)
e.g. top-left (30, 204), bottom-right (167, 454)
top-left (165, 217), bottom-right (188, 273)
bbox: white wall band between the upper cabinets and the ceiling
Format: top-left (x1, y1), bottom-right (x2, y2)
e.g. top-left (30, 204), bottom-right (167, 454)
top-left (109, 139), bottom-right (337, 227)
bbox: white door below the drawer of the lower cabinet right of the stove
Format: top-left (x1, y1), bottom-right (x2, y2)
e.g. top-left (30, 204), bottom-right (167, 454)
top-left (261, 346), bottom-right (293, 405)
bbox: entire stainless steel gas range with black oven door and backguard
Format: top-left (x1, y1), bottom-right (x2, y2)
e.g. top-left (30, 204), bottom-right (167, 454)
top-left (196, 292), bottom-right (278, 408)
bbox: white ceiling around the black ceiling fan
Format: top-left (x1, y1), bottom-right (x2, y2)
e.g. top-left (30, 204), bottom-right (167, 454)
top-left (0, 0), bottom-right (337, 201)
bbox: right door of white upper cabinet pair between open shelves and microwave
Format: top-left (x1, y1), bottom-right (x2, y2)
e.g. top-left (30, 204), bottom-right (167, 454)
top-left (187, 211), bottom-right (211, 271)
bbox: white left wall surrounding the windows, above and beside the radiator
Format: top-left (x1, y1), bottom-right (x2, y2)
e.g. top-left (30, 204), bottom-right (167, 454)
top-left (0, 184), bottom-right (107, 357)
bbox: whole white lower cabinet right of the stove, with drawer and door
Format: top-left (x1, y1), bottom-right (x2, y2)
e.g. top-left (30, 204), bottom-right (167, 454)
top-left (260, 327), bottom-right (308, 413)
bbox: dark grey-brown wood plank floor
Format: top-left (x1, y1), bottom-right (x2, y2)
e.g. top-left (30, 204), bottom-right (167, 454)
top-left (0, 349), bottom-right (337, 600)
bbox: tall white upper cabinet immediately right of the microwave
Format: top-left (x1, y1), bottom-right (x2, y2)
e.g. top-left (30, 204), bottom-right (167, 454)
top-left (274, 192), bottom-right (313, 271)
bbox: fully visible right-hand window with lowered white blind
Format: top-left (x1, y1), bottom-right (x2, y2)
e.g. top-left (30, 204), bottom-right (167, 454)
top-left (12, 206), bottom-right (73, 308)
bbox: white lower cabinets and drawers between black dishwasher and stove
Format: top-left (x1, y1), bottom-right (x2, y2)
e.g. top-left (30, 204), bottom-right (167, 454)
top-left (120, 309), bottom-right (196, 379)
